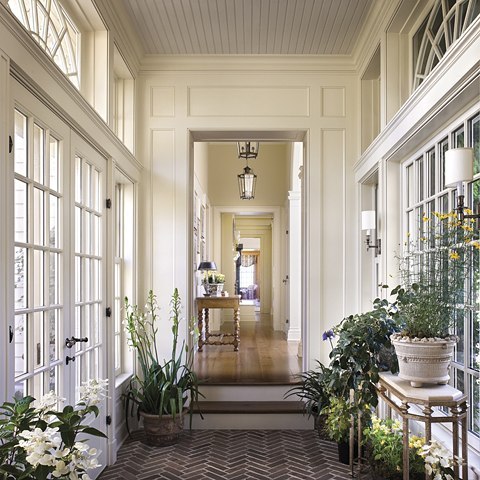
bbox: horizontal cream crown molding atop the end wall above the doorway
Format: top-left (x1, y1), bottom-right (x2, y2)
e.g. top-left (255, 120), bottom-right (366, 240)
top-left (140, 55), bottom-right (355, 74)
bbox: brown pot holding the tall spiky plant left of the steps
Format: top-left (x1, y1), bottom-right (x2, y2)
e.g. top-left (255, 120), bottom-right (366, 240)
top-left (140, 410), bottom-right (185, 447)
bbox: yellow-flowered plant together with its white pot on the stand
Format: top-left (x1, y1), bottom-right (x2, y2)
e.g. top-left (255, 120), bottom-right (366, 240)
top-left (392, 212), bottom-right (480, 387)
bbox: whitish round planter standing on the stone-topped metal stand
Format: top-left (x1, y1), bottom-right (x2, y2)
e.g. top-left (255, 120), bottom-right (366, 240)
top-left (391, 334), bottom-right (457, 387)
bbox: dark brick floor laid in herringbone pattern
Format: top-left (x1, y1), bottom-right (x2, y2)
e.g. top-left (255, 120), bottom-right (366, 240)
top-left (99, 430), bottom-right (351, 480)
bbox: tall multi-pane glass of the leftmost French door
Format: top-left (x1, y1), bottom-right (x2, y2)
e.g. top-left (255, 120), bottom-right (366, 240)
top-left (14, 110), bottom-right (64, 397)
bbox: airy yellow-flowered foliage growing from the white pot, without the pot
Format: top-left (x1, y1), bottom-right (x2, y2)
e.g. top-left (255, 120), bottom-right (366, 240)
top-left (392, 212), bottom-right (480, 339)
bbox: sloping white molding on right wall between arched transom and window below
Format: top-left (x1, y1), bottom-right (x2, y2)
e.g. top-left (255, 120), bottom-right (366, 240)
top-left (354, 17), bottom-right (480, 182)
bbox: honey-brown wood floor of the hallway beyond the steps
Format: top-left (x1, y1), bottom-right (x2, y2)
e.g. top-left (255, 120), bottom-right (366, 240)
top-left (194, 313), bottom-right (302, 384)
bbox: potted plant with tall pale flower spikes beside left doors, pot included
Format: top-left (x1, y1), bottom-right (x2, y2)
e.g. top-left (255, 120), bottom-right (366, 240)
top-left (124, 289), bottom-right (200, 446)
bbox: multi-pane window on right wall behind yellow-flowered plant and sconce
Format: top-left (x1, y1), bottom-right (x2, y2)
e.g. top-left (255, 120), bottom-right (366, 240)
top-left (404, 112), bottom-right (480, 437)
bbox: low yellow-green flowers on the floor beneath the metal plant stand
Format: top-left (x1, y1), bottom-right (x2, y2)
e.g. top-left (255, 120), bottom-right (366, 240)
top-left (363, 415), bottom-right (425, 480)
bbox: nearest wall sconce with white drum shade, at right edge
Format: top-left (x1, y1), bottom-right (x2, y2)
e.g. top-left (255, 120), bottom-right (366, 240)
top-left (445, 148), bottom-right (480, 223)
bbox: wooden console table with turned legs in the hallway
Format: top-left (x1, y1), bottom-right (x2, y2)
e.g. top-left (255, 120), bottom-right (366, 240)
top-left (197, 295), bottom-right (240, 352)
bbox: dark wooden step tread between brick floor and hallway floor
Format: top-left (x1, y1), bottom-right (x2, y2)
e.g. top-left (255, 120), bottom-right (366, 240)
top-left (197, 401), bottom-right (304, 414)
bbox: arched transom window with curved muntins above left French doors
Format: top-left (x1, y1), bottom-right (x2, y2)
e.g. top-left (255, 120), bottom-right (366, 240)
top-left (8, 0), bottom-right (80, 88)
